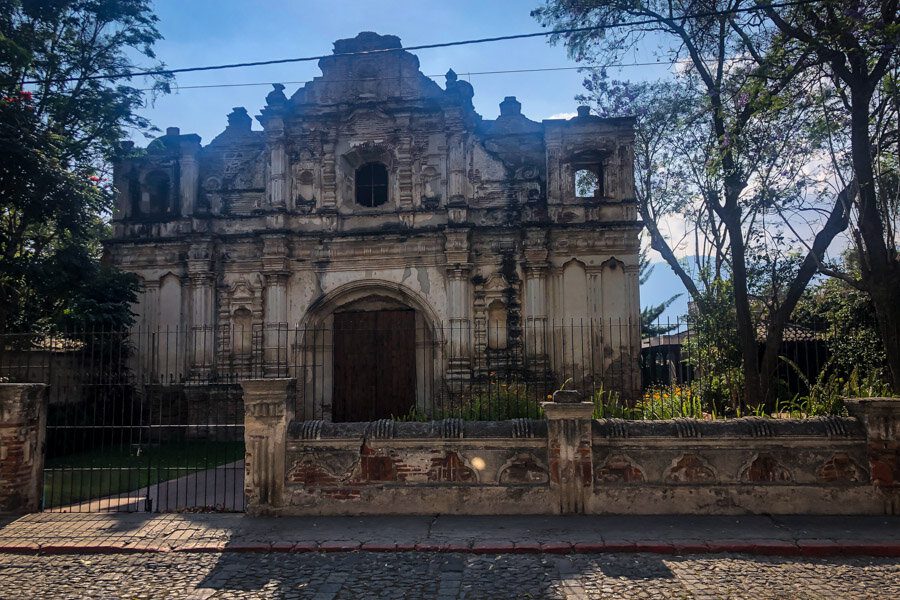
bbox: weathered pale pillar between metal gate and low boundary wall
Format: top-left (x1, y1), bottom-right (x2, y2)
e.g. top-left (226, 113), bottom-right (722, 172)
top-left (241, 379), bottom-right (297, 515)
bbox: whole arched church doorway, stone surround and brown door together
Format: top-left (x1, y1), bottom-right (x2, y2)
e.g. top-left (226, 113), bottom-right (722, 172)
top-left (302, 280), bottom-right (440, 422)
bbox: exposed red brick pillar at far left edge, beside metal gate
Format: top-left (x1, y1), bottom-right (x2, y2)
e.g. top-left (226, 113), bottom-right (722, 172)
top-left (0, 383), bottom-right (48, 514)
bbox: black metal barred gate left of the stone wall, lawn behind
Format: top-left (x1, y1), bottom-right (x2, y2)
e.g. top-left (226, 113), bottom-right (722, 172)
top-left (0, 330), bottom-right (244, 512)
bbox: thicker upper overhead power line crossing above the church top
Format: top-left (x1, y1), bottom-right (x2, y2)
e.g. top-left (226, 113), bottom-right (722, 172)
top-left (24, 0), bottom-right (820, 85)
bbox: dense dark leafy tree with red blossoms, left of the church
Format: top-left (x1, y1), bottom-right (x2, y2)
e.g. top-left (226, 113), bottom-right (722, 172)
top-left (0, 0), bottom-right (167, 329)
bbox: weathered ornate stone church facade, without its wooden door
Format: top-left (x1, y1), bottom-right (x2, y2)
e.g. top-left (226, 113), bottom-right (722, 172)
top-left (107, 33), bottom-right (640, 419)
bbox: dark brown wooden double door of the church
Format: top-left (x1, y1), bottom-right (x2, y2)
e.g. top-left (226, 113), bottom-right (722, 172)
top-left (332, 310), bottom-right (416, 422)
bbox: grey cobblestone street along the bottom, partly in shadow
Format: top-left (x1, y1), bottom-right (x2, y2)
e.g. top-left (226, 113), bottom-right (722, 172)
top-left (0, 552), bottom-right (900, 600)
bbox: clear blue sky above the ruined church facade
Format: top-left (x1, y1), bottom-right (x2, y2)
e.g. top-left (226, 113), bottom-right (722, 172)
top-left (135, 0), bottom-right (680, 314)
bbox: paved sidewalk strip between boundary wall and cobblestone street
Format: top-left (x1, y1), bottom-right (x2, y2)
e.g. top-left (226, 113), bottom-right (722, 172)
top-left (0, 513), bottom-right (900, 556)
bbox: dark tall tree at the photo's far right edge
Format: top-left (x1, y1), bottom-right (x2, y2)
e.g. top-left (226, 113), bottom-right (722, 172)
top-left (756, 0), bottom-right (900, 390)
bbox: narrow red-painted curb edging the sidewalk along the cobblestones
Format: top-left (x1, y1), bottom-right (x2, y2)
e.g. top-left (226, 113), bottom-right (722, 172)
top-left (0, 540), bottom-right (900, 557)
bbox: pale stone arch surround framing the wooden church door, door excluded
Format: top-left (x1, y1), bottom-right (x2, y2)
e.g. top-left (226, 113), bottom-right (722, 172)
top-left (294, 279), bottom-right (445, 420)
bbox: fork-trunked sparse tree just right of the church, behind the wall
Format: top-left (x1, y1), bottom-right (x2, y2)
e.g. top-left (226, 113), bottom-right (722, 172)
top-left (532, 0), bottom-right (851, 406)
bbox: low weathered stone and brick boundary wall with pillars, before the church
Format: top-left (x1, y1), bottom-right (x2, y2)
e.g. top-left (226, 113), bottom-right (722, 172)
top-left (243, 379), bottom-right (900, 515)
